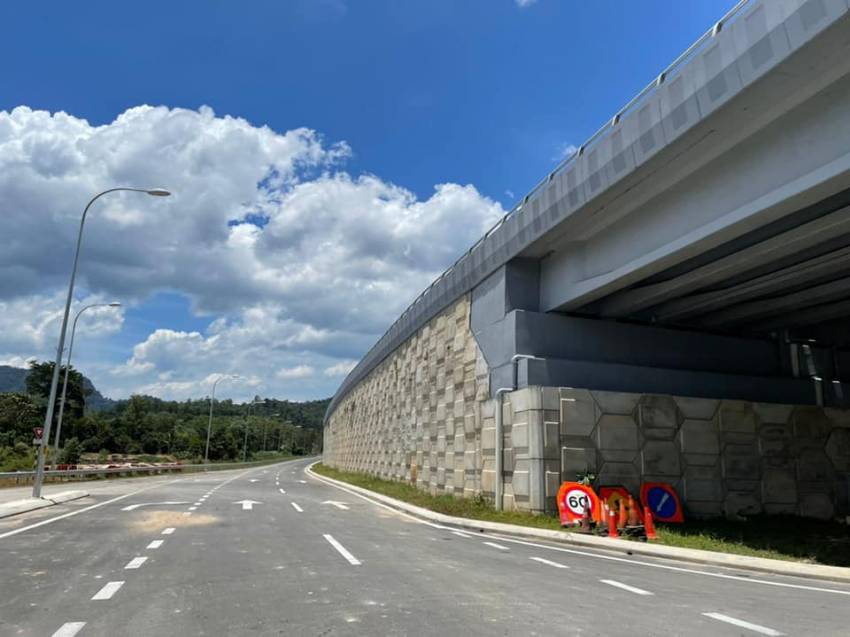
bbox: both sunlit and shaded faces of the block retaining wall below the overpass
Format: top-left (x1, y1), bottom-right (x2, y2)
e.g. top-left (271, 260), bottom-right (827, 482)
top-left (324, 297), bottom-right (850, 518)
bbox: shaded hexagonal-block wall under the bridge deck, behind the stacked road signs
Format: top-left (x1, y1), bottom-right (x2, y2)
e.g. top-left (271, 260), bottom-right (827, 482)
top-left (552, 388), bottom-right (850, 518)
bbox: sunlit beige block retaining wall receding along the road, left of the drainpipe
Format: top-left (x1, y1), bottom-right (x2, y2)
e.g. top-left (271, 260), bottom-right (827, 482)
top-left (323, 297), bottom-right (495, 497)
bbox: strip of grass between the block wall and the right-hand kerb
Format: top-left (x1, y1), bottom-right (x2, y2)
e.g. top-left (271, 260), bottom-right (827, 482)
top-left (313, 463), bottom-right (850, 566)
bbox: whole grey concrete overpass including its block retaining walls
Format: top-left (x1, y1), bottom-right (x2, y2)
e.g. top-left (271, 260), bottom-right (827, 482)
top-left (325, 0), bottom-right (850, 517)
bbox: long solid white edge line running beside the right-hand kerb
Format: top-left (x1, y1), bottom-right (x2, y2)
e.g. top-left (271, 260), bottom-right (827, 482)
top-left (310, 462), bottom-right (850, 596)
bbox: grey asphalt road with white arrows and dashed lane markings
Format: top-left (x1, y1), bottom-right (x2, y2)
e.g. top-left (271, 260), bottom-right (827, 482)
top-left (0, 460), bottom-right (850, 637)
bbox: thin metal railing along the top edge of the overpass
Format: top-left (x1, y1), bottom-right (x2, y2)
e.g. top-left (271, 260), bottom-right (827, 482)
top-left (325, 0), bottom-right (760, 421)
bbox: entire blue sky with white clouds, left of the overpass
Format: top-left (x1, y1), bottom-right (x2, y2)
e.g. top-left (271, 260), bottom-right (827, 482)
top-left (0, 0), bottom-right (732, 400)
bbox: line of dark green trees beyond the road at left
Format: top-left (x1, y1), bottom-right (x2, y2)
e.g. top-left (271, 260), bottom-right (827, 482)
top-left (0, 362), bottom-right (330, 471)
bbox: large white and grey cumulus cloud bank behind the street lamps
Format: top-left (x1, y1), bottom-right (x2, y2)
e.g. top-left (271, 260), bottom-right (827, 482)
top-left (0, 106), bottom-right (504, 397)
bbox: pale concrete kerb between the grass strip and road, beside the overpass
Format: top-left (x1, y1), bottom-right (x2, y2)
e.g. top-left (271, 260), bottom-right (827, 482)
top-left (306, 463), bottom-right (850, 582)
